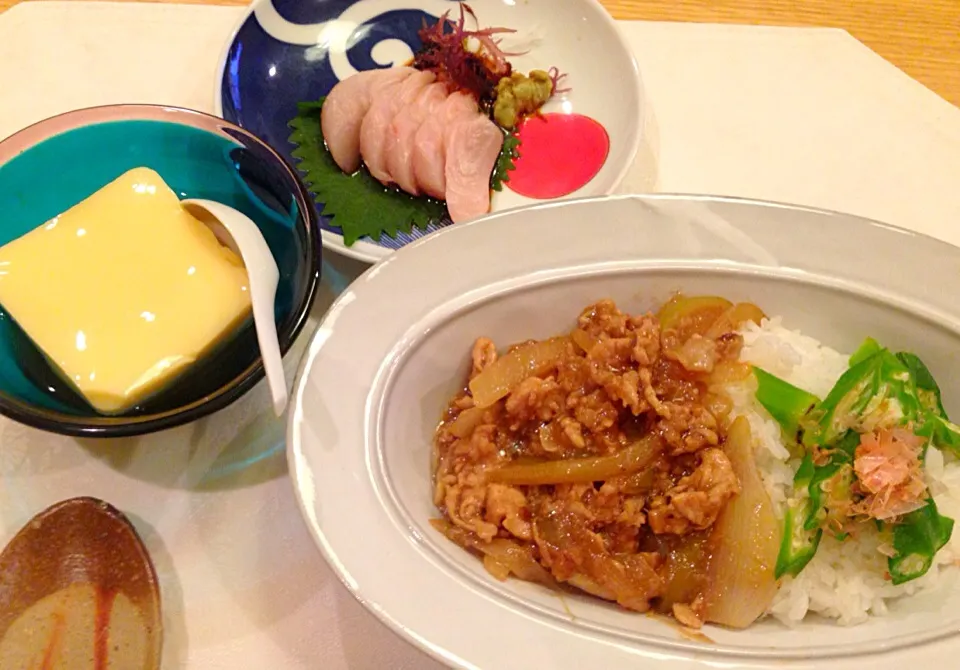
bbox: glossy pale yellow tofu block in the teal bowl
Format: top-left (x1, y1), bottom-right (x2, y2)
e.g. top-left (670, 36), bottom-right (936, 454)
top-left (0, 168), bottom-right (251, 414)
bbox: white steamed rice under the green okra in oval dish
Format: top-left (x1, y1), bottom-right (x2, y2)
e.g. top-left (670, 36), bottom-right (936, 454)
top-left (729, 318), bottom-right (960, 625)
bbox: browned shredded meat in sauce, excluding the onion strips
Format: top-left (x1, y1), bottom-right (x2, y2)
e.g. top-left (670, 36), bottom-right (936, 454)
top-left (435, 300), bottom-right (752, 625)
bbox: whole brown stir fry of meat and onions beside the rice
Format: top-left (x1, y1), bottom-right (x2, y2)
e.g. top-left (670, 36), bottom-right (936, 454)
top-left (434, 296), bottom-right (780, 627)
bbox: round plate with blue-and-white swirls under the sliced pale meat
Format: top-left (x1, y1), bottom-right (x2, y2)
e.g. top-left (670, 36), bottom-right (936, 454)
top-left (214, 0), bottom-right (643, 262)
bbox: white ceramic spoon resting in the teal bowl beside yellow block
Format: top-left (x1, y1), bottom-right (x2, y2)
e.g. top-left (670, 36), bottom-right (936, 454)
top-left (180, 199), bottom-right (287, 416)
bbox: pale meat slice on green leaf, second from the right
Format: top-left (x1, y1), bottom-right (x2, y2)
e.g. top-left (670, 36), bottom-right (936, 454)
top-left (411, 93), bottom-right (479, 200)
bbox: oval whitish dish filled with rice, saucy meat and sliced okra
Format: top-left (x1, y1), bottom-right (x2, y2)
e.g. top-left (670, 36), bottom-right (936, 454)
top-left (288, 196), bottom-right (960, 669)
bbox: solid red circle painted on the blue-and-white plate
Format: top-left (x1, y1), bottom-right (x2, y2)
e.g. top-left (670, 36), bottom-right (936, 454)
top-left (506, 113), bottom-right (610, 200)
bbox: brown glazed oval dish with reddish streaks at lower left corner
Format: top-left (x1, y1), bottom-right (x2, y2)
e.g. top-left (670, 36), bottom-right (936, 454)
top-left (0, 498), bottom-right (162, 670)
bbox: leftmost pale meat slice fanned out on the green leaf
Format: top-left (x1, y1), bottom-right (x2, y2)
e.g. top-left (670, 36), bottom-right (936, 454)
top-left (320, 67), bottom-right (414, 174)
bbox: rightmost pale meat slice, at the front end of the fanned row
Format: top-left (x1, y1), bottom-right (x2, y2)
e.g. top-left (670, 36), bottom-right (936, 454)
top-left (444, 114), bottom-right (503, 223)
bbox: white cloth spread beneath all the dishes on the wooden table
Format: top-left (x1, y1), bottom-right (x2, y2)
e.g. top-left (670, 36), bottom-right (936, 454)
top-left (0, 2), bottom-right (960, 670)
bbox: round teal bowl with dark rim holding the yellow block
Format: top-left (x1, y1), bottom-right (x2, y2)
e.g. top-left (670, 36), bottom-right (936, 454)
top-left (0, 105), bottom-right (321, 437)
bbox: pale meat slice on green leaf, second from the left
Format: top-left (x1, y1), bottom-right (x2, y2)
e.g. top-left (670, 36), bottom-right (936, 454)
top-left (360, 68), bottom-right (437, 184)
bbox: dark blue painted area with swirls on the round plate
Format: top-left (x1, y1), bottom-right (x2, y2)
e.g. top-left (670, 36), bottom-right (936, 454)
top-left (220, 0), bottom-right (456, 249)
